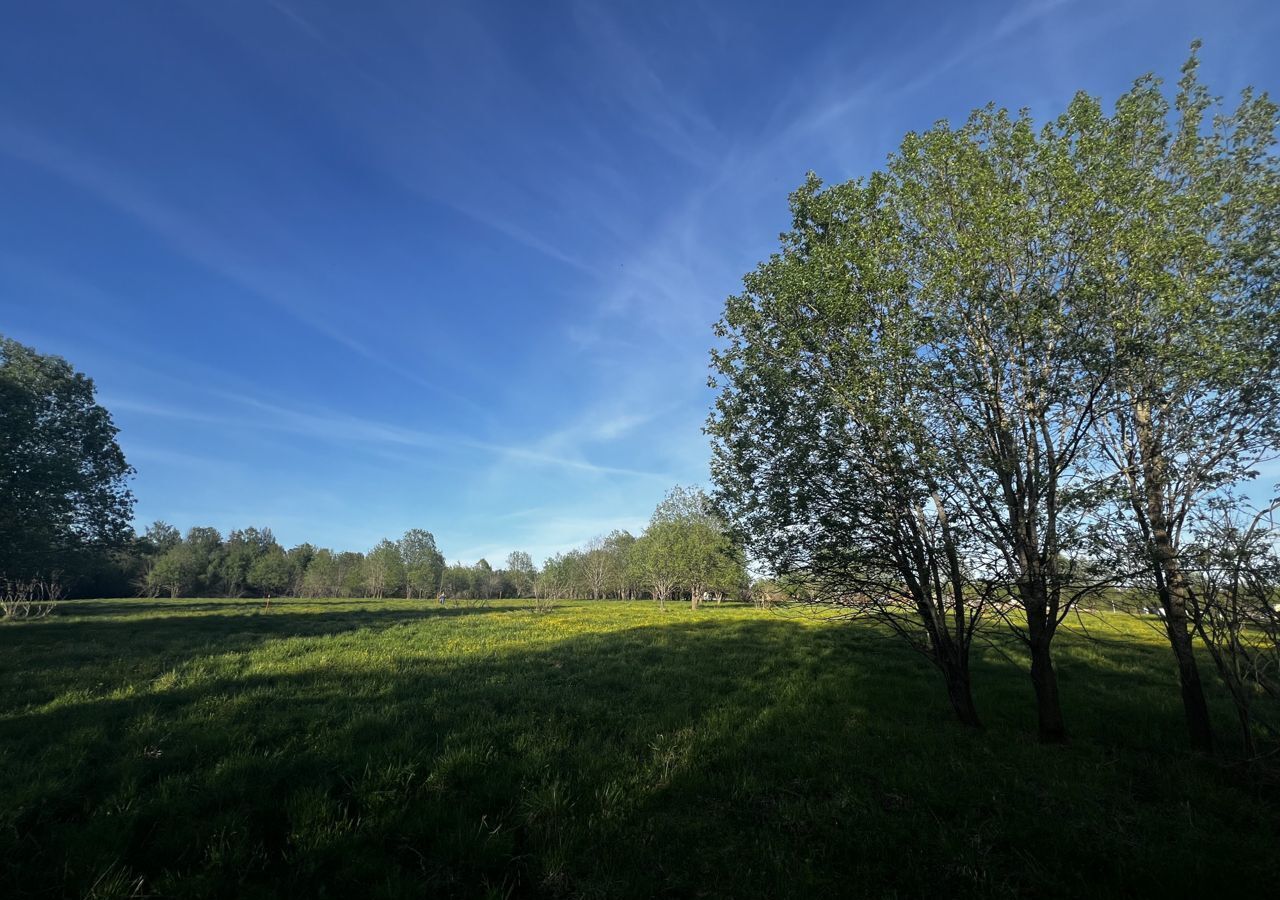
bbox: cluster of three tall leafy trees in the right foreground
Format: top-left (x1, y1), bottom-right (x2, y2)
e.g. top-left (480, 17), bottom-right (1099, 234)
top-left (710, 45), bottom-right (1280, 749)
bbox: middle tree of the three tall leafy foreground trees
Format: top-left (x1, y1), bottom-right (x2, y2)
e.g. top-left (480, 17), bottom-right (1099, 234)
top-left (890, 100), bottom-right (1110, 741)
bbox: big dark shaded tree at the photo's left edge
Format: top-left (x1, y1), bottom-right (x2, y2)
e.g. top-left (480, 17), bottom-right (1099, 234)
top-left (0, 337), bottom-right (133, 577)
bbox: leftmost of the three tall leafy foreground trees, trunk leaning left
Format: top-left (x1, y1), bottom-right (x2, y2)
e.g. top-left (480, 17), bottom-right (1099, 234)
top-left (709, 174), bottom-right (982, 726)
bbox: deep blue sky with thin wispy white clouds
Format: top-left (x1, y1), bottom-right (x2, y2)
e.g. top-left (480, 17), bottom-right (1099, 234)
top-left (0, 0), bottom-right (1280, 562)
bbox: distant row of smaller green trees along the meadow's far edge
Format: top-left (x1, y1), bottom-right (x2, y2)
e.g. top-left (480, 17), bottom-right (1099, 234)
top-left (55, 488), bottom-right (750, 607)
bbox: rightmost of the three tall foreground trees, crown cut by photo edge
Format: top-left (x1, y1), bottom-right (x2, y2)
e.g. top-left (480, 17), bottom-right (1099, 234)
top-left (1087, 47), bottom-right (1280, 751)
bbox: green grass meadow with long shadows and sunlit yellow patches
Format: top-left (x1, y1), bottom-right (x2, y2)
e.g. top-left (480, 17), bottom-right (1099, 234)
top-left (0, 600), bottom-right (1280, 897)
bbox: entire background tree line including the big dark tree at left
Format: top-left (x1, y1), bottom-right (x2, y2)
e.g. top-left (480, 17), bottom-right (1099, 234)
top-left (0, 338), bottom-right (750, 615)
